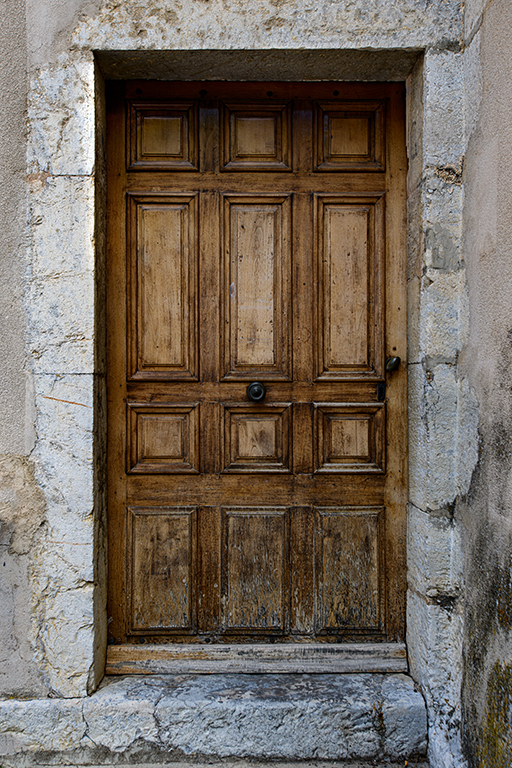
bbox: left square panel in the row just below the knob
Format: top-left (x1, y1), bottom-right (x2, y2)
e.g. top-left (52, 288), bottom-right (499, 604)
top-left (128, 403), bottom-right (199, 474)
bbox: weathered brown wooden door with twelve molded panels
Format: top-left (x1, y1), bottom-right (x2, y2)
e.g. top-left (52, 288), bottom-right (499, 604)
top-left (107, 82), bottom-right (406, 660)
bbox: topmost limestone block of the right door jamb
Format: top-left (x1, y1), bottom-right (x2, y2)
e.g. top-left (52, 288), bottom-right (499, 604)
top-left (423, 49), bottom-right (464, 167)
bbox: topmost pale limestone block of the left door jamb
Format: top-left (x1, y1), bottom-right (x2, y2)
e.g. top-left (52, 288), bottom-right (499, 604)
top-left (28, 57), bottom-right (95, 176)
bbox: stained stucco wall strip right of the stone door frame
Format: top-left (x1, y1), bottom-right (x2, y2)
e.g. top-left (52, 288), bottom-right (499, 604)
top-left (457, 0), bottom-right (512, 768)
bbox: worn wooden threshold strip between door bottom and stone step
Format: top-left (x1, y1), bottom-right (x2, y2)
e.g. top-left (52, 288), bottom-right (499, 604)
top-left (105, 643), bottom-right (408, 675)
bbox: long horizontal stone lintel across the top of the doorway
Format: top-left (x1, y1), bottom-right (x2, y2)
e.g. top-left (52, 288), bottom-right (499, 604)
top-left (73, 0), bottom-right (462, 50)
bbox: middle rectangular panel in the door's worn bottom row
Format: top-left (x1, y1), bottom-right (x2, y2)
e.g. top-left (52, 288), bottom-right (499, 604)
top-left (222, 507), bottom-right (289, 634)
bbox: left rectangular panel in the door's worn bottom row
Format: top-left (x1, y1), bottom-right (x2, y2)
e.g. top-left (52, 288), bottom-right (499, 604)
top-left (127, 507), bottom-right (197, 635)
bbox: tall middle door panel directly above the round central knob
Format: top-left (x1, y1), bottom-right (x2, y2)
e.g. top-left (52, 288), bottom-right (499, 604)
top-left (222, 195), bottom-right (292, 380)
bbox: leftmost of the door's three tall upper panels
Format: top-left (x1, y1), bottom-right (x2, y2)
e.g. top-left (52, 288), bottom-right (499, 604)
top-left (128, 192), bottom-right (199, 381)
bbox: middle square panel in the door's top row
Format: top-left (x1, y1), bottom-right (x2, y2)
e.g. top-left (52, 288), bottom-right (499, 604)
top-left (222, 101), bottom-right (292, 171)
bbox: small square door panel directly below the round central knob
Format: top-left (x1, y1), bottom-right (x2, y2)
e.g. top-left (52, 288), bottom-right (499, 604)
top-left (223, 404), bottom-right (291, 473)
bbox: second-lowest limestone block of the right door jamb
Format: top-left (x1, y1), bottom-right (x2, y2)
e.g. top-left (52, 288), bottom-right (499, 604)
top-left (407, 504), bottom-right (463, 599)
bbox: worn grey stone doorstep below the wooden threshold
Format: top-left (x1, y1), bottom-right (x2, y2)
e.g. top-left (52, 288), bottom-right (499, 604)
top-left (0, 674), bottom-right (427, 768)
